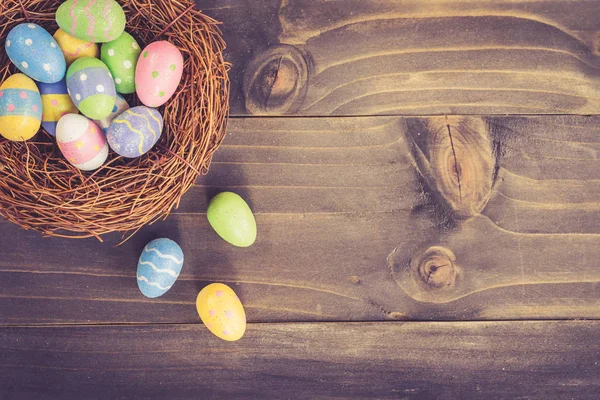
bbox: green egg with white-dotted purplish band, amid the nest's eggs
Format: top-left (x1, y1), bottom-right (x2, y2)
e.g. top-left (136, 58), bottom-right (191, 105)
top-left (67, 57), bottom-right (117, 119)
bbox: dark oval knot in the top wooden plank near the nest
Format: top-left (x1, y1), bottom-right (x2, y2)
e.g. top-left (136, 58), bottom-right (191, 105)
top-left (243, 45), bottom-right (308, 115)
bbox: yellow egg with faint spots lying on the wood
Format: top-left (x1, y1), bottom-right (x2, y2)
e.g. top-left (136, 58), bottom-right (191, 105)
top-left (196, 283), bottom-right (246, 342)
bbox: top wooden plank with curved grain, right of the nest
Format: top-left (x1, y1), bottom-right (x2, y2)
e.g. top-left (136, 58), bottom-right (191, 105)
top-left (196, 0), bottom-right (600, 115)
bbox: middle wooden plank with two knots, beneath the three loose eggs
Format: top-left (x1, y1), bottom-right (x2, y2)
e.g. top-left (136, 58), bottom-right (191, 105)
top-left (0, 117), bottom-right (600, 325)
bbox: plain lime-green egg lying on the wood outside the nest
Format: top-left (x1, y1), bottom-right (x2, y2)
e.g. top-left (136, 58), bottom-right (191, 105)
top-left (206, 192), bottom-right (256, 247)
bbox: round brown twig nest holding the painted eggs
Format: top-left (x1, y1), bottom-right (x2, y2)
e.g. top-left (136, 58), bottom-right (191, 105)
top-left (0, 0), bottom-right (229, 239)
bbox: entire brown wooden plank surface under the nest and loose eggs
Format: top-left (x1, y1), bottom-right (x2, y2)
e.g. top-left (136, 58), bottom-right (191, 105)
top-left (0, 0), bottom-right (600, 399)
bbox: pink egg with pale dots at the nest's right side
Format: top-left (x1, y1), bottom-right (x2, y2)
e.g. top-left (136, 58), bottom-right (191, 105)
top-left (135, 40), bottom-right (183, 107)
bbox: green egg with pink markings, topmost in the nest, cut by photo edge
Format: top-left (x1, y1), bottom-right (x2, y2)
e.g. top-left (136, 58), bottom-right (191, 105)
top-left (56, 0), bottom-right (125, 43)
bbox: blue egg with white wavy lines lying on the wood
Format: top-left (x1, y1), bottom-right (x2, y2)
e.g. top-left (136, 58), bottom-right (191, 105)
top-left (137, 238), bottom-right (183, 299)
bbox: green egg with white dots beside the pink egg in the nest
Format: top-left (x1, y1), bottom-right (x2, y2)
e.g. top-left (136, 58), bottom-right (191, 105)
top-left (100, 32), bottom-right (142, 94)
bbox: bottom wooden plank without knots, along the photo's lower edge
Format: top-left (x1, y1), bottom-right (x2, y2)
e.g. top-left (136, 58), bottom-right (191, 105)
top-left (0, 321), bottom-right (600, 400)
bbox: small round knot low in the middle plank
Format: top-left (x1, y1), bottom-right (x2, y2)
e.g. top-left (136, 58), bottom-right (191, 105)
top-left (416, 246), bottom-right (456, 290)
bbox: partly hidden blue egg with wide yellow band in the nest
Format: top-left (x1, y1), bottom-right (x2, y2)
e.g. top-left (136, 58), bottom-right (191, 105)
top-left (38, 79), bottom-right (78, 136)
